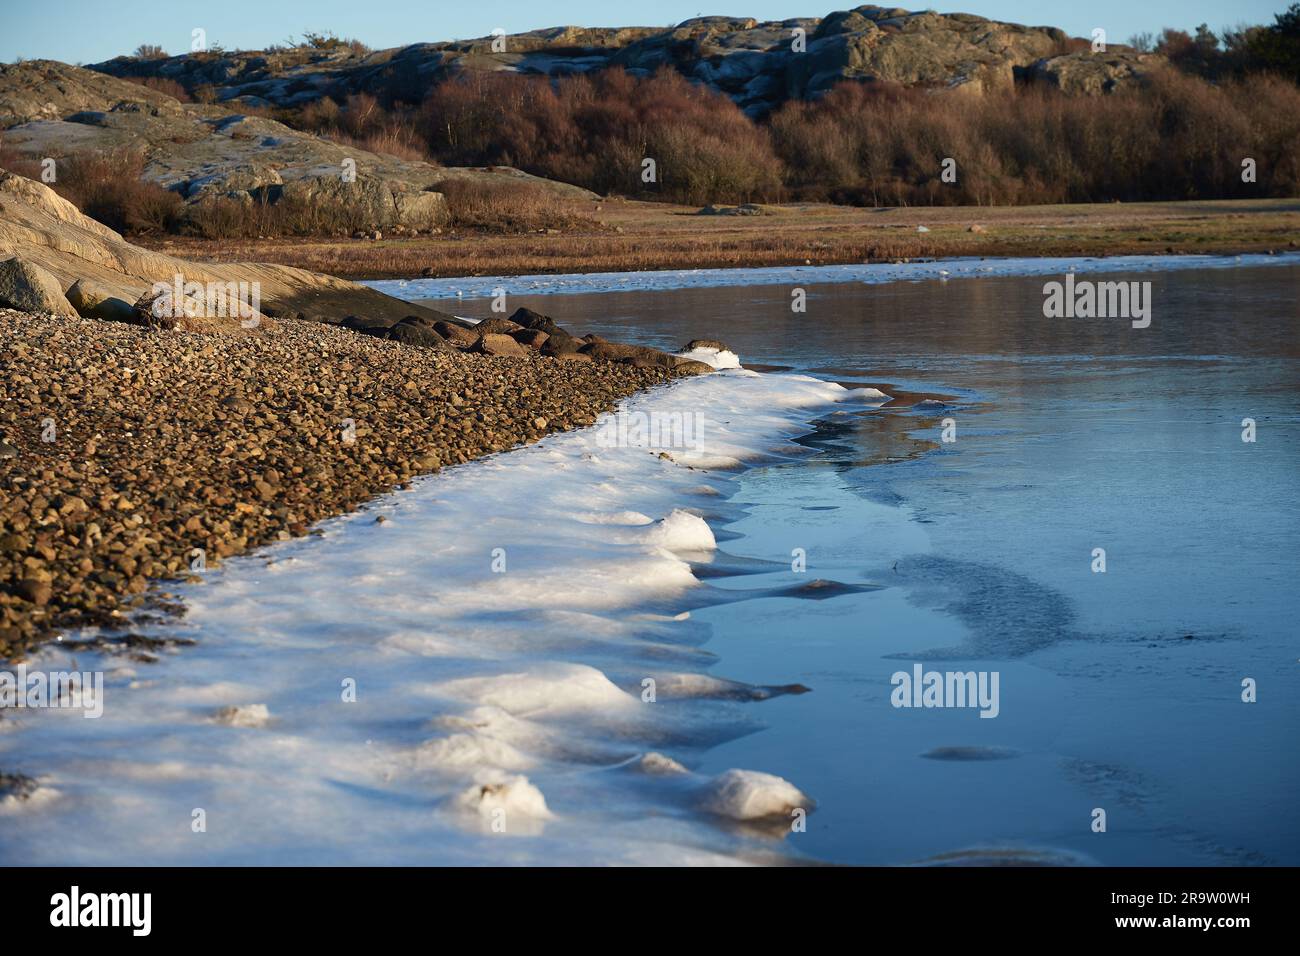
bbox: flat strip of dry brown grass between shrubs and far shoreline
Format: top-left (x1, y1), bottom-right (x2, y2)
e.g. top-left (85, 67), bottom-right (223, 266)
top-left (139, 200), bottom-right (1300, 278)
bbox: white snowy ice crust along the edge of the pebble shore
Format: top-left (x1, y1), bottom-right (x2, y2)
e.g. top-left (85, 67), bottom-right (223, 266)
top-left (0, 369), bottom-right (884, 865)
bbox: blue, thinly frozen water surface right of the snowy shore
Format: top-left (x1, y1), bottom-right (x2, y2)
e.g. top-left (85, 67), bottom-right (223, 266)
top-left (434, 265), bottom-right (1300, 865)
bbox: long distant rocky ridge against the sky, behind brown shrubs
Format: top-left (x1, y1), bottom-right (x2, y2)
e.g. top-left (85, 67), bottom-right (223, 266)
top-left (91, 5), bottom-right (1158, 117)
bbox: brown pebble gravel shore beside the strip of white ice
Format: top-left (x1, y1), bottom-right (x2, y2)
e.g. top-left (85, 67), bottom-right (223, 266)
top-left (0, 310), bottom-right (677, 659)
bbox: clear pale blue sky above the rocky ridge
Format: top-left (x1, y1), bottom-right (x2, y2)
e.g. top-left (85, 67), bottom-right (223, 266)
top-left (0, 0), bottom-right (1287, 62)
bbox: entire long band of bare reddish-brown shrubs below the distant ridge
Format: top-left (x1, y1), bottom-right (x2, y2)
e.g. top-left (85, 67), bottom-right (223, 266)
top-left (250, 64), bottom-right (1300, 206)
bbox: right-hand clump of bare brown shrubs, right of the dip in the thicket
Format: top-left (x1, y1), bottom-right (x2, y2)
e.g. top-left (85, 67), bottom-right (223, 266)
top-left (771, 70), bottom-right (1300, 206)
